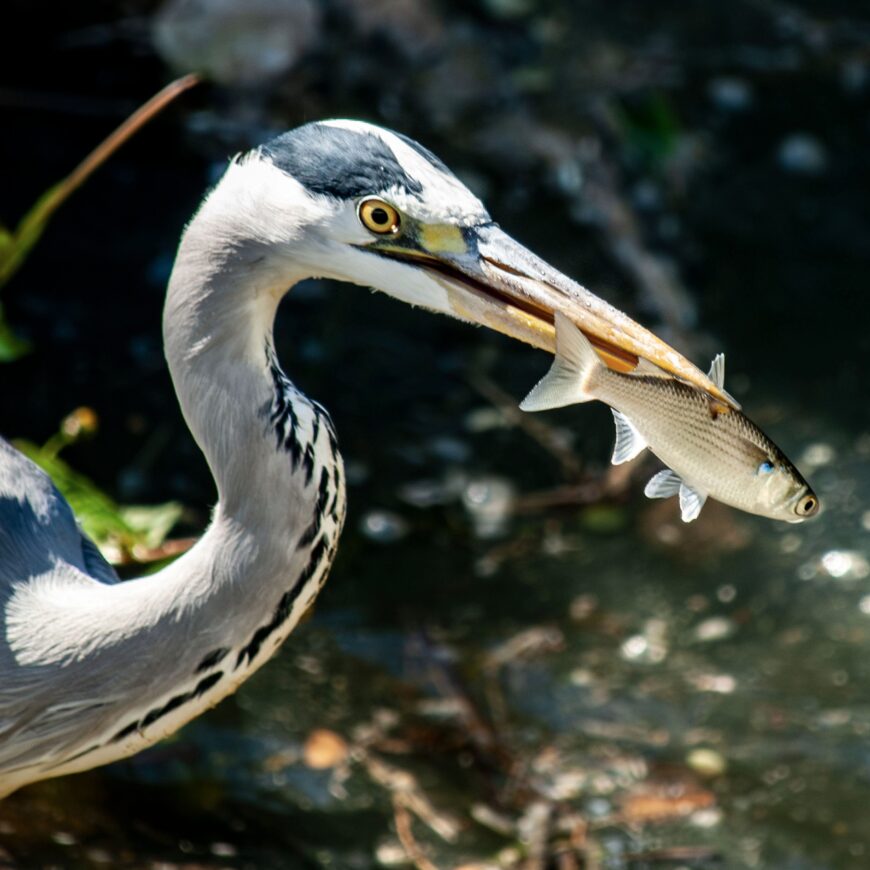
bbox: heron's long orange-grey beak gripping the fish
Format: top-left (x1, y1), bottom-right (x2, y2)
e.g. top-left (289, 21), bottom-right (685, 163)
top-left (384, 224), bottom-right (739, 407)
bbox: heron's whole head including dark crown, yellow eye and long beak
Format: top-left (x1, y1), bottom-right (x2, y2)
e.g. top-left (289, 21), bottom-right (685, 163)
top-left (216, 120), bottom-right (732, 404)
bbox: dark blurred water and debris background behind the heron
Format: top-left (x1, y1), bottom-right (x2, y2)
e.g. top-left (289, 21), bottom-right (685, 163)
top-left (0, 0), bottom-right (870, 870)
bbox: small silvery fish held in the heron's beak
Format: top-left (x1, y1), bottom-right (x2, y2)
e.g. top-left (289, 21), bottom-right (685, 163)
top-left (520, 312), bottom-right (819, 523)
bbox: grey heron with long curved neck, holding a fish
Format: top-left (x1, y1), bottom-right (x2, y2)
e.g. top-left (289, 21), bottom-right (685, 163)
top-left (0, 121), bottom-right (727, 796)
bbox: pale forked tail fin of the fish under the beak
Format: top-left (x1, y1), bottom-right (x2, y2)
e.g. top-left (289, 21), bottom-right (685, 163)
top-left (520, 311), bottom-right (603, 411)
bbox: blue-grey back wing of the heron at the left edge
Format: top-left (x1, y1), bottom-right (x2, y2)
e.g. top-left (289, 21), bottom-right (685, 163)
top-left (0, 438), bottom-right (118, 588)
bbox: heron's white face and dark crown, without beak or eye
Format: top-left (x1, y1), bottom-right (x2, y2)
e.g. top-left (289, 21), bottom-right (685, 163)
top-left (211, 121), bottom-right (490, 316)
